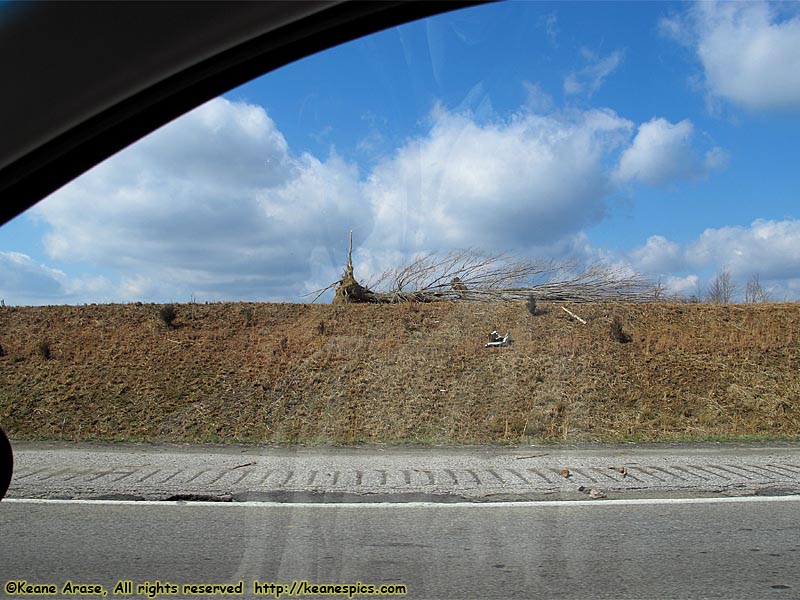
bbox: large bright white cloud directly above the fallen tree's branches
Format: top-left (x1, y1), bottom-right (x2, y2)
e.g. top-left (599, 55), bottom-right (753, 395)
top-left (365, 105), bottom-right (633, 262)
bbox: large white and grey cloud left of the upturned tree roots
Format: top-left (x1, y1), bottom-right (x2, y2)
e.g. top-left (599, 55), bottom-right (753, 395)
top-left (34, 99), bottom-right (370, 300)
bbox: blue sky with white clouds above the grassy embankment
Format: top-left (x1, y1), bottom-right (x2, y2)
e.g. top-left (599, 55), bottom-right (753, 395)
top-left (0, 2), bottom-right (800, 304)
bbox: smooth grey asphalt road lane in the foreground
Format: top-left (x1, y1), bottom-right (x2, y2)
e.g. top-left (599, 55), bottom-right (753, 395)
top-left (0, 496), bottom-right (800, 600)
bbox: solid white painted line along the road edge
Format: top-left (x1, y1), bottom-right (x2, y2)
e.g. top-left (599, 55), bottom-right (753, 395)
top-left (0, 495), bottom-right (800, 510)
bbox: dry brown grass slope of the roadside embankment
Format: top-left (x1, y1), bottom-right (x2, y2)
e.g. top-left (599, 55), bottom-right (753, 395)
top-left (0, 302), bottom-right (800, 443)
